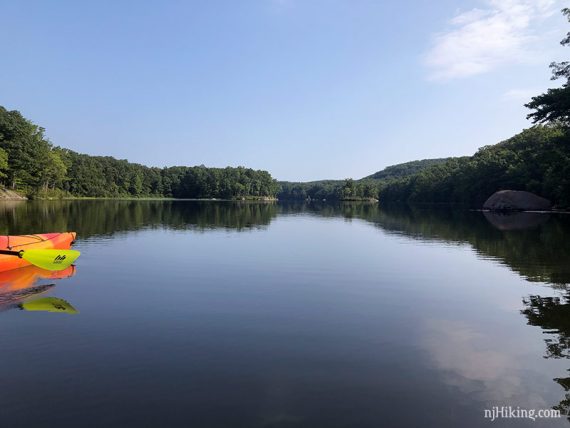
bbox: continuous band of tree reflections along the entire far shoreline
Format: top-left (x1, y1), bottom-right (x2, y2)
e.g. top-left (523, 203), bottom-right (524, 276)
top-left (0, 200), bottom-right (570, 285)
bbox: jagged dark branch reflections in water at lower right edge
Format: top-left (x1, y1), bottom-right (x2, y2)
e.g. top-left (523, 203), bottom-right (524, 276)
top-left (521, 293), bottom-right (570, 420)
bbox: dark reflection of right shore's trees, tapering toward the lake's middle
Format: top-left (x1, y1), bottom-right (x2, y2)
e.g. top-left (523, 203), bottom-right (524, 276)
top-left (289, 203), bottom-right (570, 286)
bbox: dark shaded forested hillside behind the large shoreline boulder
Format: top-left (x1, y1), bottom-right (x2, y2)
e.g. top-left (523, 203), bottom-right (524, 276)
top-left (380, 125), bottom-right (570, 207)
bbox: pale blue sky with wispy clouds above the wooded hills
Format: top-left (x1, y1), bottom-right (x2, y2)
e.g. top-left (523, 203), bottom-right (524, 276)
top-left (0, 0), bottom-right (570, 181)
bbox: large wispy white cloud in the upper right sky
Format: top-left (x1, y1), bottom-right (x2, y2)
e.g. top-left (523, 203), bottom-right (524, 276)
top-left (424, 0), bottom-right (557, 80)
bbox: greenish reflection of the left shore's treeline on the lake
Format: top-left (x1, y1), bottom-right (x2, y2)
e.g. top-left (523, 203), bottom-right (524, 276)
top-left (0, 200), bottom-right (277, 238)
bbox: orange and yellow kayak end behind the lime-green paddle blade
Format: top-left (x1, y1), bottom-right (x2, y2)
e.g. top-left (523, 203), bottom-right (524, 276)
top-left (0, 232), bottom-right (76, 272)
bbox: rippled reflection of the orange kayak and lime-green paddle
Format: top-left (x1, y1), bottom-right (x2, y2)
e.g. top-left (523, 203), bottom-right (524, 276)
top-left (0, 266), bottom-right (78, 314)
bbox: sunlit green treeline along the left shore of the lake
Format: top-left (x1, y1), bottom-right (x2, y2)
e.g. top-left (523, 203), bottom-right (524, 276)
top-left (0, 106), bottom-right (278, 199)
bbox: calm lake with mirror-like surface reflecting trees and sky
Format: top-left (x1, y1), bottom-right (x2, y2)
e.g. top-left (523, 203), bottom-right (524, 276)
top-left (0, 201), bottom-right (570, 427)
